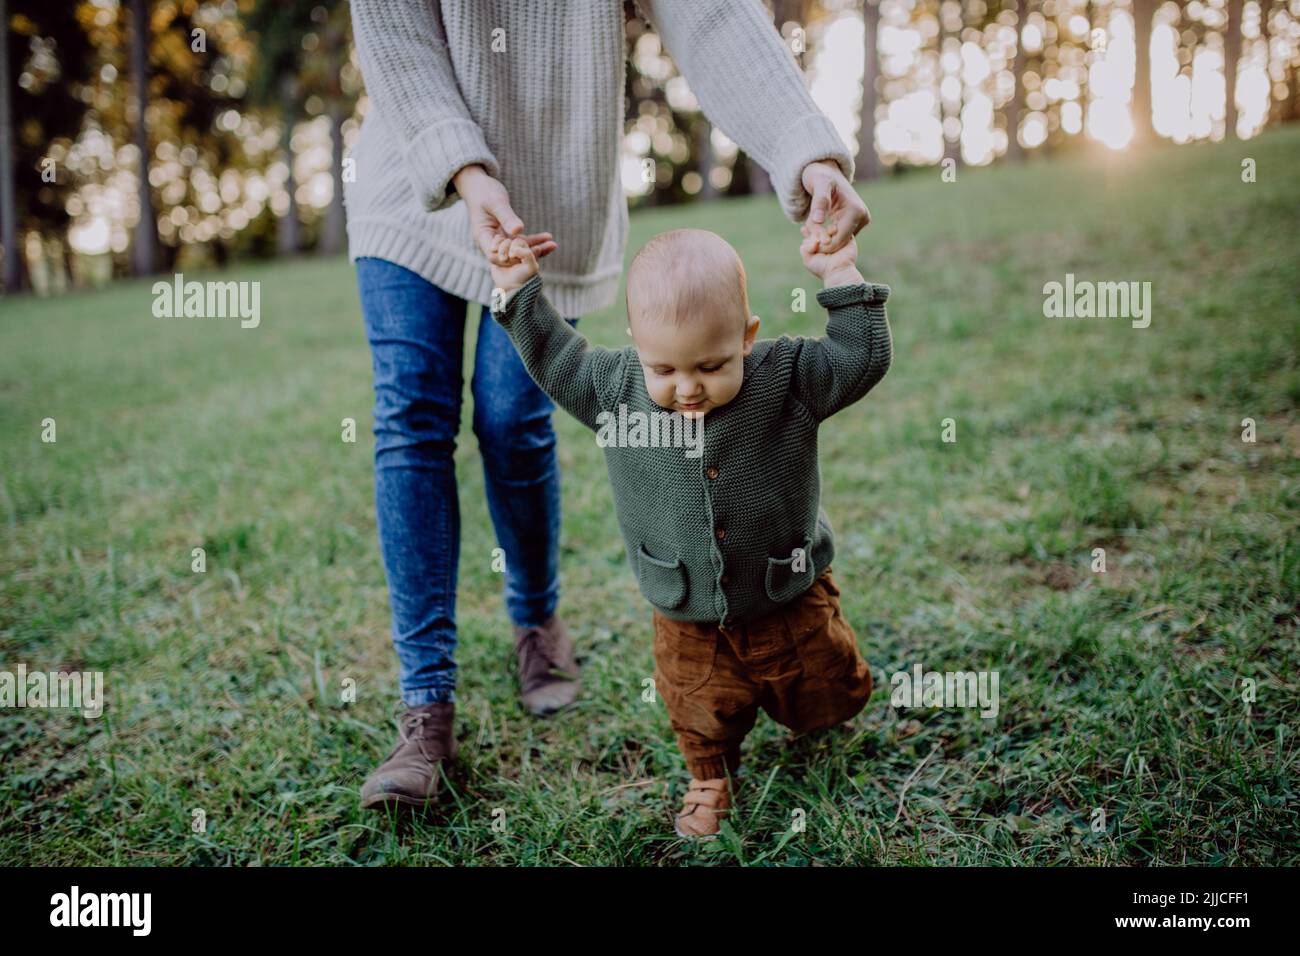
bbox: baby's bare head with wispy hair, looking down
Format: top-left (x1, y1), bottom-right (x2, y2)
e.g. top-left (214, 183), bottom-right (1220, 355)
top-left (628, 229), bottom-right (758, 418)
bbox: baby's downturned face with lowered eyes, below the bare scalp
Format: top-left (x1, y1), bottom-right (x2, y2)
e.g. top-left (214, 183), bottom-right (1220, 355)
top-left (632, 308), bottom-right (758, 418)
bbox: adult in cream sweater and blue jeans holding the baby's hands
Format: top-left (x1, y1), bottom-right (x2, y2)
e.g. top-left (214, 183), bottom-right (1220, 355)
top-left (346, 0), bottom-right (868, 806)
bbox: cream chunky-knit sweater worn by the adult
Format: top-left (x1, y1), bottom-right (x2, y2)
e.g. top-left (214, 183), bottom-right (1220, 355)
top-left (345, 0), bottom-right (853, 317)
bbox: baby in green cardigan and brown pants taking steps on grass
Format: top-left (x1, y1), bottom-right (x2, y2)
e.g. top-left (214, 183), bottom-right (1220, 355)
top-left (489, 225), bottom-right (893, 838)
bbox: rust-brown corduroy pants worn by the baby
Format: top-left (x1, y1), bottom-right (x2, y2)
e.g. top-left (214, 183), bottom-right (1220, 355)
top-left (654, 567), bottom-right (872, 779)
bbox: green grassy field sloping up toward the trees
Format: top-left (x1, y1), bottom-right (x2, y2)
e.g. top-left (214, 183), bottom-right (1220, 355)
top-left (0, 126), bottom-right (1300, 865)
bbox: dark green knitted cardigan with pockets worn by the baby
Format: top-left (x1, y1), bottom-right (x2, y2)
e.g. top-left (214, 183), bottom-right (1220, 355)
top-left (493, 273), bottom-right (893, 626)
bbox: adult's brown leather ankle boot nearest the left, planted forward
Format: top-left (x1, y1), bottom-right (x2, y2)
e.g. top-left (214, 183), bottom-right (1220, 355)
top-left (361, 701), bottom-right (458, 809)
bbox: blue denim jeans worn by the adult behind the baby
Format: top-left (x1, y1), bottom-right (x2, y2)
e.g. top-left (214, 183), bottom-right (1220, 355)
top-left (356, 258), bottom-right (577, 706)
